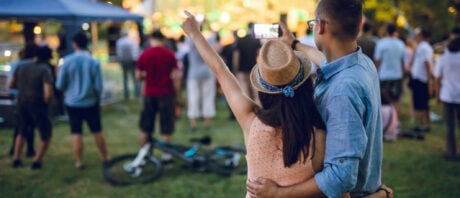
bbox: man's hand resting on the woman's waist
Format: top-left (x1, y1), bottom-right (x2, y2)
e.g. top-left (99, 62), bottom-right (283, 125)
top-left (246, 178), bottom-right (279, 198)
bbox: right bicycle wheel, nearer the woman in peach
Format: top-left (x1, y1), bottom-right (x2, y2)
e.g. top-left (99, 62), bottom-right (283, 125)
top-left (206, 145), bottom-right (247, 176)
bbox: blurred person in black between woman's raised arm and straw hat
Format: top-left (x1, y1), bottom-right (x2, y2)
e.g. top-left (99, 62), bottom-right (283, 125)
top-left (233, 22), bottom-right (261, 101)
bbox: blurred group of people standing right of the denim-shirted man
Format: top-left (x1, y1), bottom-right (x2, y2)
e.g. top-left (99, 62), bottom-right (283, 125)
top-left (358, 18), bottom-right (460, 145)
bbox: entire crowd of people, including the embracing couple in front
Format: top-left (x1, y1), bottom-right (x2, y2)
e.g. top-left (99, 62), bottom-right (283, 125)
top-left (5, 0), bottom-right (460, 197)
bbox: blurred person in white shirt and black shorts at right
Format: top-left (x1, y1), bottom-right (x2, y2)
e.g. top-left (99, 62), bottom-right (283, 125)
top-left (410, 28), bottom-right (434, 136)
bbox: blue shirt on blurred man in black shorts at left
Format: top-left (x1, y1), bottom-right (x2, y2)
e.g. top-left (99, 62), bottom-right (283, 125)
top-left (56, 51), bottom-right (103, 107)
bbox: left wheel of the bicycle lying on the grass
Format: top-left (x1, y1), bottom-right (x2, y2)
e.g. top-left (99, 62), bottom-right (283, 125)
top-left (103, 154), bottom-right (162, 185)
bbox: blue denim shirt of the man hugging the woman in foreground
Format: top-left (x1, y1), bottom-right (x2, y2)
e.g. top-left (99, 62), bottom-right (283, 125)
top-left (315, 49), bottom-right (383, 197)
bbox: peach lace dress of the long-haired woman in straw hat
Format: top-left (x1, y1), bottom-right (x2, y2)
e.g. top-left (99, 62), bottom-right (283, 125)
top-left (244, 117), bottom-right (315, 197)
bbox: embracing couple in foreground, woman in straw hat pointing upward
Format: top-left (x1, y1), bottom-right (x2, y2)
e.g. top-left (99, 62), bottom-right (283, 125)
top-left (182, 0), bottom-right (392, 197)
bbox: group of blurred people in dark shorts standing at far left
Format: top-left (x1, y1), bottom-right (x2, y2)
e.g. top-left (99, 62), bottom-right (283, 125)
top-left (9, 33), bottom-right (109, 169)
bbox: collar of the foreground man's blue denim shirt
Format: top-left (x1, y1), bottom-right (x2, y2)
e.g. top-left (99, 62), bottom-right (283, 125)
top-left (318, 47), bottom-right (362, 80)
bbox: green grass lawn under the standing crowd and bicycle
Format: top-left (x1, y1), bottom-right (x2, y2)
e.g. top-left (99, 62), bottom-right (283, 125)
top-left (0, 66), bottom-right (460, 198)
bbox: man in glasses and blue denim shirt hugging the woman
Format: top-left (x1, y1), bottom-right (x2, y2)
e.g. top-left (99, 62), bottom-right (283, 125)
top-left (247, 0), bottom-right (391, 197)
